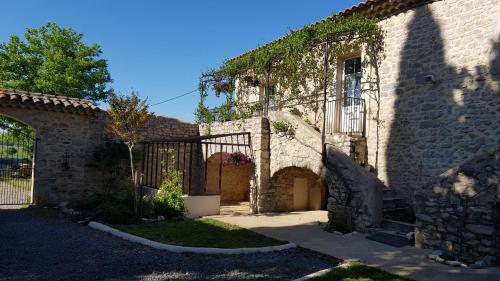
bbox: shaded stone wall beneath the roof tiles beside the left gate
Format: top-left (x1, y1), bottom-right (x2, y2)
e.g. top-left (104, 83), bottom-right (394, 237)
top-left (0, 106), bottom-right (105, 205)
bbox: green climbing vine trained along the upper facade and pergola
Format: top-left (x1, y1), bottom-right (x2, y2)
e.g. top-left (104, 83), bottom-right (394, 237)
top-left (195, 16), bottom-right (382, 124)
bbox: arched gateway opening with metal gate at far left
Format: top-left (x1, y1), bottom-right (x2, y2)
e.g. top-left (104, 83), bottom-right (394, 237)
top-left (0, 115), bottom-right (36, 205)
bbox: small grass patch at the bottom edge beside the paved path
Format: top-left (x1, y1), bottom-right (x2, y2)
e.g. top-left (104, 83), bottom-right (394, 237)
top-left (311, 263), bottom-right (409, 281)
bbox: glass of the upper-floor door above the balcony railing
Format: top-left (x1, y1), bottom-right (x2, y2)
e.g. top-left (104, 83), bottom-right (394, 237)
top-left (343, 57), bottom-right (361, 104)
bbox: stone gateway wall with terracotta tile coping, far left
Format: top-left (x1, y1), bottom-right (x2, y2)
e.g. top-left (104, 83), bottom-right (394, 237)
top-left (0, 89), bottom-right (106, 205)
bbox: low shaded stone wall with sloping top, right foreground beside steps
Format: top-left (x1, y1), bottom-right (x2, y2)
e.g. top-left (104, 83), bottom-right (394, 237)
top-left (415, 149), bottom-right (500, 263)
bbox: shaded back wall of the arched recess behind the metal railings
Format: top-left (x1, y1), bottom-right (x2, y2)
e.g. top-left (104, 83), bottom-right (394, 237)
top-left (206, 152), bottom-right (253, 202)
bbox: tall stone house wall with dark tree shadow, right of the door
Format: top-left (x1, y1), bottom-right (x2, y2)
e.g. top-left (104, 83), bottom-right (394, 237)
top-left (364, 0), bottom-right (500, 202)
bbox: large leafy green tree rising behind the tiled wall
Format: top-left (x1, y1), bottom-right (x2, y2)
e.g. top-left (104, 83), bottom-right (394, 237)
top-left (0, 23), bottom-right (112, 102)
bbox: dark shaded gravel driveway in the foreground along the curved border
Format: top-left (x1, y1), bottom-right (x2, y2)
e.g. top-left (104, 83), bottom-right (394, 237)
top-left (0, 208), bottom-right (336, 281)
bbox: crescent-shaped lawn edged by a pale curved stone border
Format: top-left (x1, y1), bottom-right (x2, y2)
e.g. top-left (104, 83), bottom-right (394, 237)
top-left (113, 218), bottom-right (287, 249)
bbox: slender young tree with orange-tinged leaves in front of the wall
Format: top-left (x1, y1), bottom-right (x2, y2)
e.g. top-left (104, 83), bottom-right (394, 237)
top-left (108, 91), bottom-right (151, 178)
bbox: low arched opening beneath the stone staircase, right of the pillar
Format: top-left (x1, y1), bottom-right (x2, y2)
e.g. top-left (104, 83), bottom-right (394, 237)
top-left (271, 167), bottom-right (326, 212)
